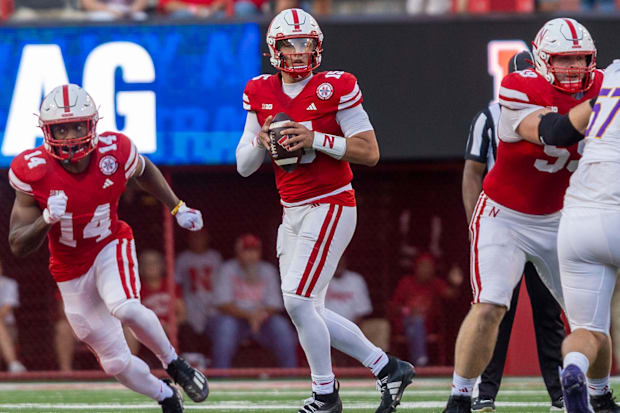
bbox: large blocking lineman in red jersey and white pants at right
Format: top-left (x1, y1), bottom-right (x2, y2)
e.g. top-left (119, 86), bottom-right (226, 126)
top-left (444, 18), bottom-right (607, 413)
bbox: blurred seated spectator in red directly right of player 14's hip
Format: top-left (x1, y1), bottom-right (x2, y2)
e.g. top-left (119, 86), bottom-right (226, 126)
top-left (125, 250), bottom-right (186, 354)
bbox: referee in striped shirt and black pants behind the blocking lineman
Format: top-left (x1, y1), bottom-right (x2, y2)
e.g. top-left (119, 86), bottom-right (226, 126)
top-left (462, 51), bottom-right (564, 412)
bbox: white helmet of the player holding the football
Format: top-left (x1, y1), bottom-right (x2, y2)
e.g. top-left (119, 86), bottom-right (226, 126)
top-left (267, 9), bottom-right (323, 76)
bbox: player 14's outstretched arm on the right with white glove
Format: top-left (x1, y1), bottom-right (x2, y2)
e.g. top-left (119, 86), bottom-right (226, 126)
top-left (132, 155), bottom-right (202, 231)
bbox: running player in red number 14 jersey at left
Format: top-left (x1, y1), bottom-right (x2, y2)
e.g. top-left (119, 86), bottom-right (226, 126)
top-left (9, 84), bottom-right (208, 413)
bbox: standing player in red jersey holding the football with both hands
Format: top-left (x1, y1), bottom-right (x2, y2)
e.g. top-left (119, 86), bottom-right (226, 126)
top-left (237, 9), bottom-right (415, 413)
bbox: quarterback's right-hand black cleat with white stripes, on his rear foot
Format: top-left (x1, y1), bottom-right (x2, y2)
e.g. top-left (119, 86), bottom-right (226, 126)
top-left (375, 356), bottom-right (415, 413)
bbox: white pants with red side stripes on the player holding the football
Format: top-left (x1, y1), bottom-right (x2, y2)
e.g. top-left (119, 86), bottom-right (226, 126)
top-left (276, 204), bottom-right (357, 298)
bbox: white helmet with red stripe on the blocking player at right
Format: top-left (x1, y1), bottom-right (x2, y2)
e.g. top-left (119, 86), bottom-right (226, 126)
top-left (532, 17), bottom-right (596, 93)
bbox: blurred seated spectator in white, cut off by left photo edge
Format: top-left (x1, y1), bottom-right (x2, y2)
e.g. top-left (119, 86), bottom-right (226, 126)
top-left (0, 264), bottom-right (26, 373)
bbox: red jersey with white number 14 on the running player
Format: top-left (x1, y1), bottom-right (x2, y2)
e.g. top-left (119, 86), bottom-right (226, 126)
top-left (9, 132), bottom-right (139, 282)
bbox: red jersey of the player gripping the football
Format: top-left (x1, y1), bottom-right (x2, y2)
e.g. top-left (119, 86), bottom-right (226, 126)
top-left (243, 72), bottom-right (362, 206)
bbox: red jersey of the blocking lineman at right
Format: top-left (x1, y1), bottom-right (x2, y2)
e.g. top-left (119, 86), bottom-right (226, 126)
top-left (482, 70), bottom-right (603, 215)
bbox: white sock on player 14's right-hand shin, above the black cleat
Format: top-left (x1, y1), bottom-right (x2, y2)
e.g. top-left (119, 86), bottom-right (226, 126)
top-left (114, 301), bottom-right (178, 368)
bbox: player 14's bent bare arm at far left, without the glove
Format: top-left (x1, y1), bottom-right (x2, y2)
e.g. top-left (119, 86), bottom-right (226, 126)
top-left (9, 191), bottom-right (51, 257)
